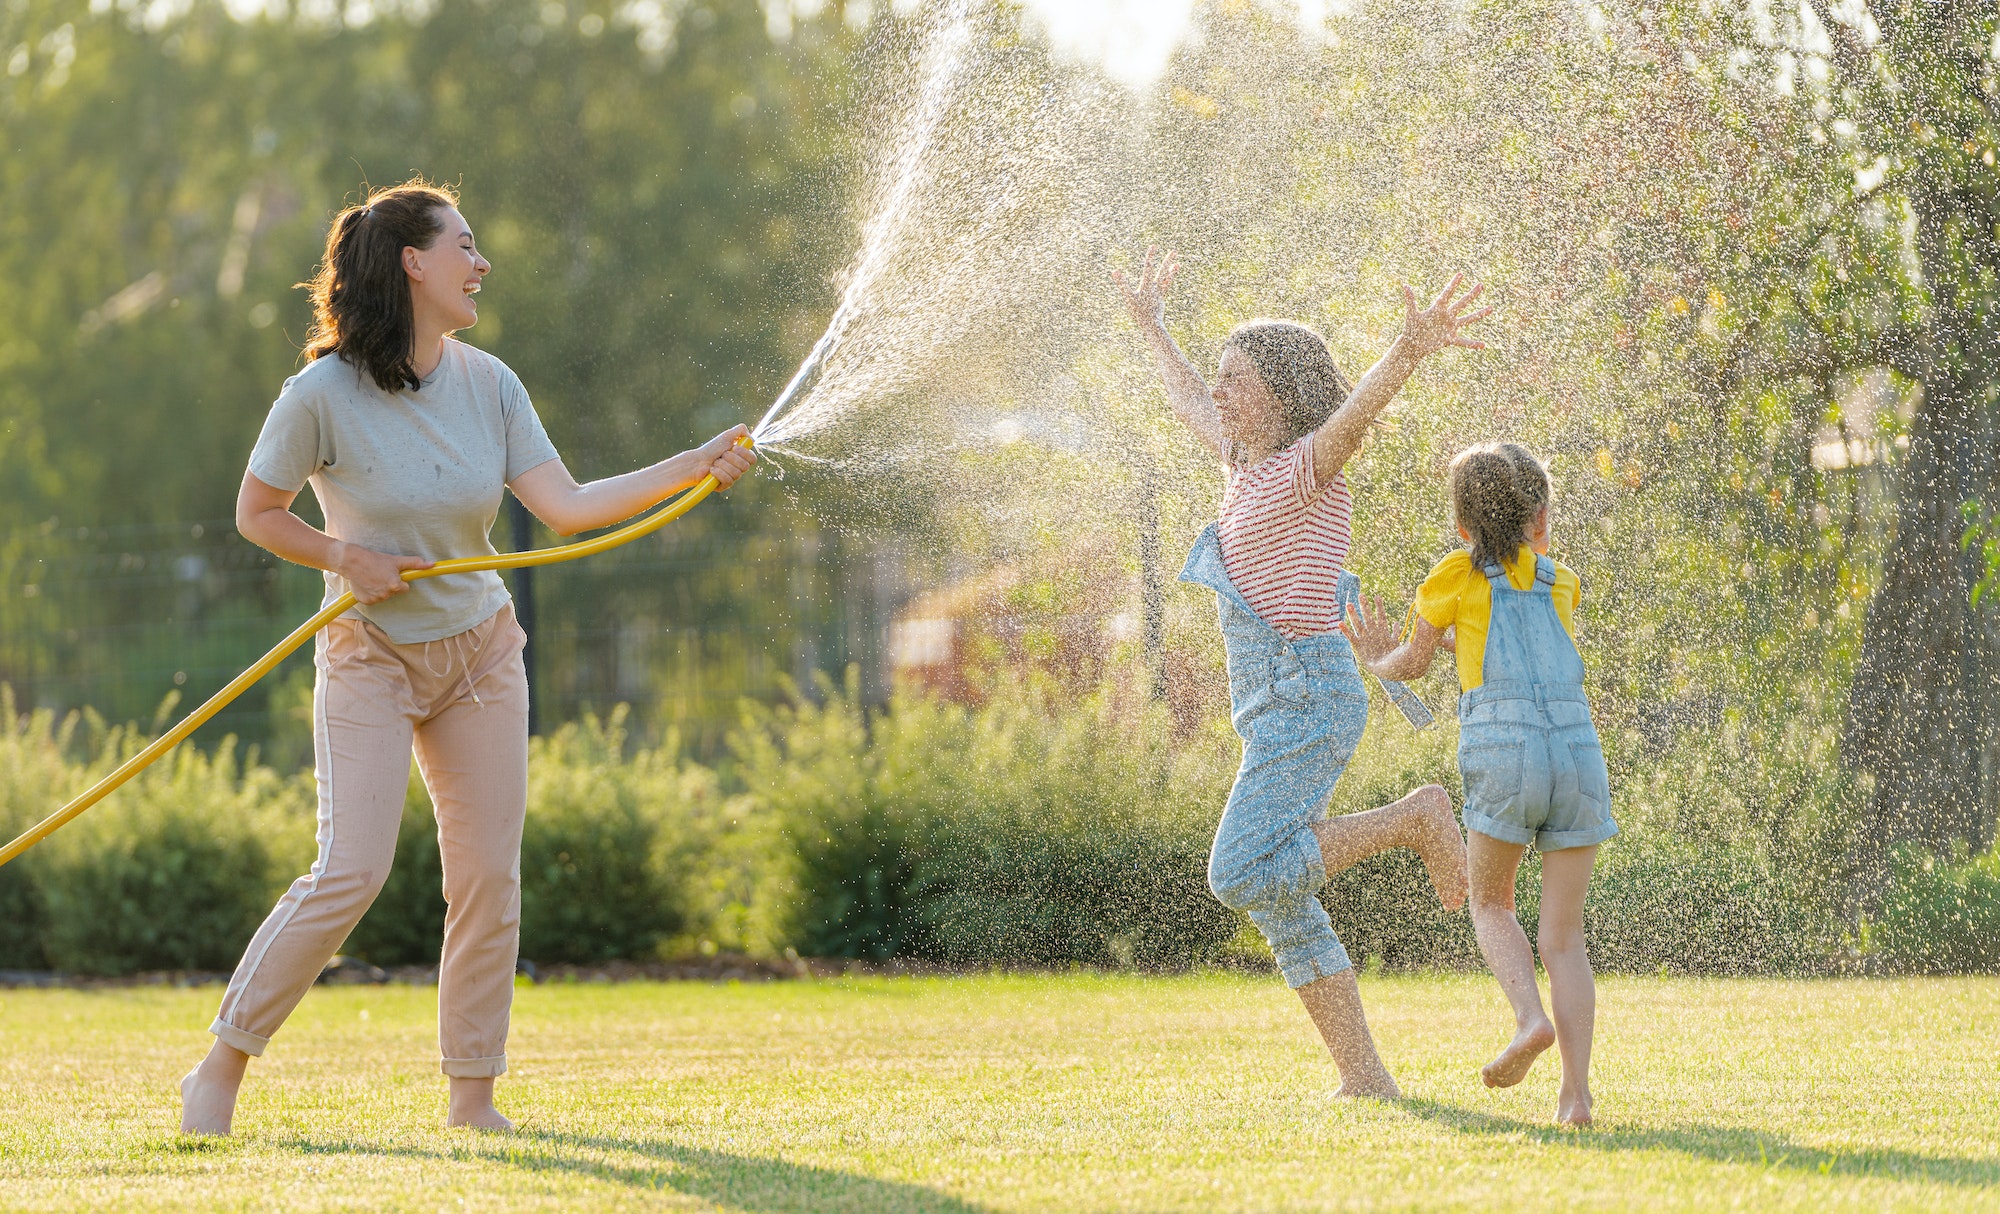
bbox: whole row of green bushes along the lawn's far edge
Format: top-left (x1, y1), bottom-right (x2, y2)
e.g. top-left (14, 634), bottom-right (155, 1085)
top-left (0, 680), bottom-right (2000, 974)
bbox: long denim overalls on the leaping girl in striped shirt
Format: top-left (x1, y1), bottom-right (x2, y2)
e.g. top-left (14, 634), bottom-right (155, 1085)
top-left (1180, 524), bottom-right (1392, 988)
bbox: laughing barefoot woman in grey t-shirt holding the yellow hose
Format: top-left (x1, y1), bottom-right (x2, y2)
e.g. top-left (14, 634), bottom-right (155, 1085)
top-left (180, 180), bottom-right (756, 1134)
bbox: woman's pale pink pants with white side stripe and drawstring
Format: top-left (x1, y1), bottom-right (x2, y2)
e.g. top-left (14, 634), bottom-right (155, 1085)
top-left (210, 606), bottom-right (528, 1078)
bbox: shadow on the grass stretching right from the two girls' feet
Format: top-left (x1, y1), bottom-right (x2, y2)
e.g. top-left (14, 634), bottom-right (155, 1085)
top-left (1402, 1100), bottom-right (2000, 1188)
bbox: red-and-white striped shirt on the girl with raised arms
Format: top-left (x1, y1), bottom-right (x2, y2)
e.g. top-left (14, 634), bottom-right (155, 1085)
top-left (1218, 434), bottom-right (1354, 640)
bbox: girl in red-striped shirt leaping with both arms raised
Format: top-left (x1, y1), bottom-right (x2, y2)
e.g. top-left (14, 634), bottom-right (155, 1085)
top-left (1114, 250), bottom-right (1492, 1100)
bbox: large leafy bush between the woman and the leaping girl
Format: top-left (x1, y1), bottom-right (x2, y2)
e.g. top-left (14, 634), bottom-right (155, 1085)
top-left (736, 680), bottom-right (1238, 968)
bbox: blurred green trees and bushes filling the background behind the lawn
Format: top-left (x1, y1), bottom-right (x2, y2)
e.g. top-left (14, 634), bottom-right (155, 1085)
top-left (0, 0), bottom-right (2000, 972)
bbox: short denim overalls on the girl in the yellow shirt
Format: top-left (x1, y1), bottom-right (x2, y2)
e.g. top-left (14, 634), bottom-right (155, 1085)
top-left (1458, 556), bottom-right (1618, 852)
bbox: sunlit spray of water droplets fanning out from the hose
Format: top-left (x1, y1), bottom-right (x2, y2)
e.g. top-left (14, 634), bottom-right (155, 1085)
top-left (758, 0), bottom-right (1894, 896)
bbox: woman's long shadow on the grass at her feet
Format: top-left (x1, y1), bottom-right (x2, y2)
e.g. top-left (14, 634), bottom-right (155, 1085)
top-left (284, 1130), bottom-right (988, 1214)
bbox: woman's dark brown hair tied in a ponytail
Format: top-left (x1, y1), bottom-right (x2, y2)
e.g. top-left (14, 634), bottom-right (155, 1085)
top-left (298, 178), bottom-right (458, 392)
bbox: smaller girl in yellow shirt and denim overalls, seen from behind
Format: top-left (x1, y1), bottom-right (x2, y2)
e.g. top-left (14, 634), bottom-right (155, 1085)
top-left (1346, 442), bottom-right (1618, 1126)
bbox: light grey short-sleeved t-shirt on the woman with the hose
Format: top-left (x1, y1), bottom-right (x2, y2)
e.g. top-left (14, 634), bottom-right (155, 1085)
top-left (250, 340), bottom-right (556, 644)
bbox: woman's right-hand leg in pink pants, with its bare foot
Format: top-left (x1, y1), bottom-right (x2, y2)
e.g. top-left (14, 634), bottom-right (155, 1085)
top-left (416, 614), bottom-right (528, 1130)
